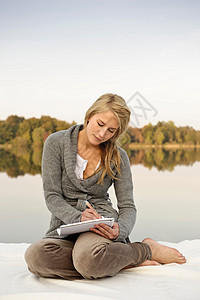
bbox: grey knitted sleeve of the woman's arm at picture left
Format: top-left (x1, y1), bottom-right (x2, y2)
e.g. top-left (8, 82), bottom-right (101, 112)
top-left (42, 132), bottom-right (81, 224)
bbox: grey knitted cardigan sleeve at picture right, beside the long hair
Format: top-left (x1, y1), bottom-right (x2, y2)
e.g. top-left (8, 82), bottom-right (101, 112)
top-left (114, 148), bottom-right (136, 241)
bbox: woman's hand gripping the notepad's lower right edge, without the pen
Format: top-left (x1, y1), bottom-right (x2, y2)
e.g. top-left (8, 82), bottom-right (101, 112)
top-left (90, 222), bottom-right (119, 240)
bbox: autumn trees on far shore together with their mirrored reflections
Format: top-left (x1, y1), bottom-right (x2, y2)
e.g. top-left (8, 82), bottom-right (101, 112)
top-left (0, 115), bottom-right (200, 177)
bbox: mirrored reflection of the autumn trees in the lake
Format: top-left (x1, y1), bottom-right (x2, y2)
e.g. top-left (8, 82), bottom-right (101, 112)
top-left (0, 148), bottom-right (200, 177)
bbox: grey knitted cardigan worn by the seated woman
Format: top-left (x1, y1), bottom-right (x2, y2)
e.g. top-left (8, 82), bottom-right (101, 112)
top-left (42, 125), bottom-right (136, 241)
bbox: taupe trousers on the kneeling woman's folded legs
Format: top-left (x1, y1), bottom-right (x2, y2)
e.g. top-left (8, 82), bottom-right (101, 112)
top-left (25, 232), bottom-right (152, 280)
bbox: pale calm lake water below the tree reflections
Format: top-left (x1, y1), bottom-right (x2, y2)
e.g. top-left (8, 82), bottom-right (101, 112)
top-left (0, 162), bottom-right (200, 243)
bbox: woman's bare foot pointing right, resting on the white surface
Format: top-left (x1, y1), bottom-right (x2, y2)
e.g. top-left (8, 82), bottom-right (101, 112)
top-left (142, 238), bottom-right (186, 264)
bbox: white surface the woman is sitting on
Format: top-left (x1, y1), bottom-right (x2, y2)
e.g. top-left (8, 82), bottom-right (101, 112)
top-left (0, 240), bottom-right (200, 300)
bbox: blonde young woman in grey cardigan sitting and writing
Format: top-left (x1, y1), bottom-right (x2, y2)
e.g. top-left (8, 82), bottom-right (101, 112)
top-left (25, 94), bottom-right (186, 280)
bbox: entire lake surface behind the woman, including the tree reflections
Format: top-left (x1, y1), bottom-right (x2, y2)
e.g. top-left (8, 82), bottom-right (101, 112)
top-left (0, 143), bottom-right (200, 242)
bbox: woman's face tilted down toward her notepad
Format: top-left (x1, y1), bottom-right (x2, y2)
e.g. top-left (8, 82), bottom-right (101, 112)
top-left (86, 110), bottom-right (119, 145)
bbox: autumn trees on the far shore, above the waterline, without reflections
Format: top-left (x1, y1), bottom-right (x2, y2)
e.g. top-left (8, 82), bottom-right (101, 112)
top-left (0, 115), bottom-right (200, 148)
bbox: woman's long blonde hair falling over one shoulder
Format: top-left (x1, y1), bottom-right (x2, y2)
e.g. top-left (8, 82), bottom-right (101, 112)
top-left (84, 93), bottom-right (131, 184)
